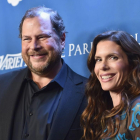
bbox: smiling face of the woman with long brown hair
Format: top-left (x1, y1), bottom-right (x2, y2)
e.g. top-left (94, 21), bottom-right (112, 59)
top-left (94, 40), bottom-right (129, 93)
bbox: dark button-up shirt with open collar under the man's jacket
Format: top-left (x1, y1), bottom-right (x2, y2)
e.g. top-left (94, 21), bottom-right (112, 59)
top-left (13, 60), bottom-right (67, 140)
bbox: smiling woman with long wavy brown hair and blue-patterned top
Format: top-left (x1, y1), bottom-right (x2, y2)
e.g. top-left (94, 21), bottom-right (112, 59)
top-left (82, 31), bottom-right (140, 140)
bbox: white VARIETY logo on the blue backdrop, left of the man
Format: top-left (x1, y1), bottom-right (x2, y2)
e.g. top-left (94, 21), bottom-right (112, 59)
top-left (0, 53), bottom-right (26, 70)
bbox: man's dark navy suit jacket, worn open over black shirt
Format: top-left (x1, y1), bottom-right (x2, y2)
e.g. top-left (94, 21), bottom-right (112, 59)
top-left (0, 63), bottom-right (87, 140)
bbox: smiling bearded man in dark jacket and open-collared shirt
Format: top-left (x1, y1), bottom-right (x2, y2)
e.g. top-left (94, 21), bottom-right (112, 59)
top-left (0, 7), bottom-right (86, 140)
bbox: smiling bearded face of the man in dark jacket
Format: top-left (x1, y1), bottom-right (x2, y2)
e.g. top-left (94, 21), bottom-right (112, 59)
top-left (22, 13), bottom-right (65, 75)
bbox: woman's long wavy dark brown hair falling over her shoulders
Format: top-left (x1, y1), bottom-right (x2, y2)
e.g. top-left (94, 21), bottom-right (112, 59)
top-left (81, 31), bottom-right (140, 140)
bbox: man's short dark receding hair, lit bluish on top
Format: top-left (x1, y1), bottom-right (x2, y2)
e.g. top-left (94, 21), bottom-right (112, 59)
top-left (19, 6), bottom-right (66, 38)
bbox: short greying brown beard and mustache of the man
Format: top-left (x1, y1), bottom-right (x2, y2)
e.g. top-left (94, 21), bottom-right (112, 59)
top-left (22, 48), bottom-right (62, 75)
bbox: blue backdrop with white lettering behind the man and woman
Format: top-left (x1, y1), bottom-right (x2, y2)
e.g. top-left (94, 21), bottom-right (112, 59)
top-left (0, 0), bottom-right (140, 77)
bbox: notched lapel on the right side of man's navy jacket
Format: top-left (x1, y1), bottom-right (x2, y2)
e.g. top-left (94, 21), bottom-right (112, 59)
top-left (48, 70), bottom-right (84, 140)
